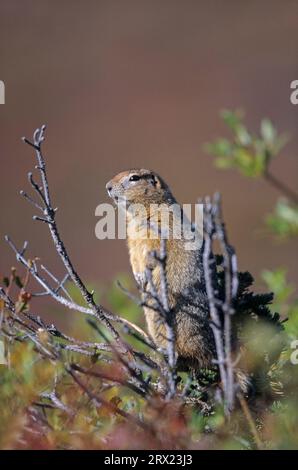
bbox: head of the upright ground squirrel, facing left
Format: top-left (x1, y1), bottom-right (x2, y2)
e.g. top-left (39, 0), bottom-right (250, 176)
top-left (106, 169), bottom-right (174, 205)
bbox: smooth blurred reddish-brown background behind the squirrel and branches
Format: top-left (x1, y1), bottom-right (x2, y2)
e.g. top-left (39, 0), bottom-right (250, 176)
top-left (0, 0), bottom-right (298, 324)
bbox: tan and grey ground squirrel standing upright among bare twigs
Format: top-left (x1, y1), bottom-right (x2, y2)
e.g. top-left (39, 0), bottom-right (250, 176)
top-left (106, 169), bottom-right (216, 371)
